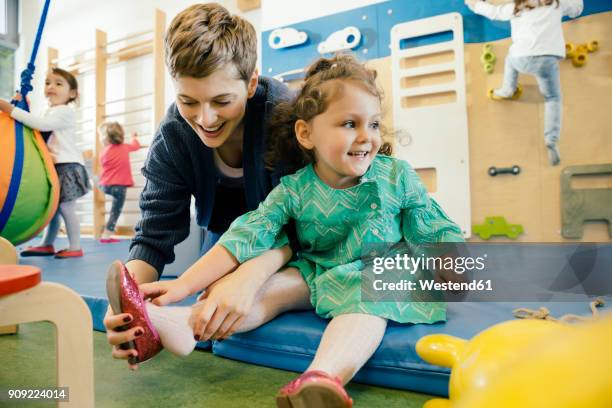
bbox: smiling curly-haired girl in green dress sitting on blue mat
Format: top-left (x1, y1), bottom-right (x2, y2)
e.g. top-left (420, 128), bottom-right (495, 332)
top-left (130, 55), bottom-right (463, 407)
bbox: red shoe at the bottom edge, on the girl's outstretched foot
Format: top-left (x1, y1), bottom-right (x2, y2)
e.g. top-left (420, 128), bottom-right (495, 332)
top-left (276, 371), bottom-right (353, 408)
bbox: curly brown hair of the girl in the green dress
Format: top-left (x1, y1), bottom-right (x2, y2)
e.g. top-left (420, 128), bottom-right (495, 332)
top-left (265, 54), bottom-right (391, 174)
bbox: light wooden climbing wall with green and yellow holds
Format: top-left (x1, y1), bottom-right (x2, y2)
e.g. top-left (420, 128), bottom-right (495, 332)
top-left (368, 12), bottom-right (612, 242)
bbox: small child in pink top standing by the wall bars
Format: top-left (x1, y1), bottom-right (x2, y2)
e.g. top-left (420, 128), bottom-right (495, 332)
top-left (98, 122), bottom-right (140, 243)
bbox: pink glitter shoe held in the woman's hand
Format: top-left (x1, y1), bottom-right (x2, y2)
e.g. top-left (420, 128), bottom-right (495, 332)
top-left (106, 261), bottom-right (162, 364)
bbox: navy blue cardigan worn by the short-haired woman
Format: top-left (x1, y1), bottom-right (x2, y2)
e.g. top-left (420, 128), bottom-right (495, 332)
top-left (128, 77), bottom-right (291, 275)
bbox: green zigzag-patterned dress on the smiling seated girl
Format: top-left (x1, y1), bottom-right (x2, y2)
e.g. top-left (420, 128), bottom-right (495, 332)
top-left (219, 155), bottom-right (463, 323)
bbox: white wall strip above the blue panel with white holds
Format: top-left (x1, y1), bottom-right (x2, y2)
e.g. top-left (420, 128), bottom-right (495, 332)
top-left (261, 0), bottom-right (387, 31)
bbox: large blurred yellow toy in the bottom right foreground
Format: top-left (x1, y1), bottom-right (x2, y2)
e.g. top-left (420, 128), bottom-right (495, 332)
top-left (416, 315), bottom-right (612, 408)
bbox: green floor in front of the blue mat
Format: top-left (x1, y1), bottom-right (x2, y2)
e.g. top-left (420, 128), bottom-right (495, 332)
top-left (0, 323), bottom-right (429, 408)
